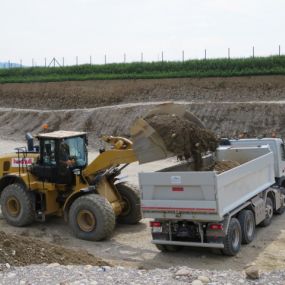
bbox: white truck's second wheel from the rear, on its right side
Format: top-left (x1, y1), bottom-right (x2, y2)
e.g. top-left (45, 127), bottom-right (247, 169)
top-left (238, 210), bottom-right (255, 244)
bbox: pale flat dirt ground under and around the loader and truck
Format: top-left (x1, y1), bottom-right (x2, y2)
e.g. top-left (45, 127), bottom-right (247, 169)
top-left (0, 140), bottom-right (285, 271)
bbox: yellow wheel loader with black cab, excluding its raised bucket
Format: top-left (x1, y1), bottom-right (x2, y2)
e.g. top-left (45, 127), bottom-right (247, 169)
top-left (0, 131), bottom-right (141, 241)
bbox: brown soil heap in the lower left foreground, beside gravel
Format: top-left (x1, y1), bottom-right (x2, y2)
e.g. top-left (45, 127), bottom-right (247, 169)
top-left (0, 231), bottom-right (109, 266)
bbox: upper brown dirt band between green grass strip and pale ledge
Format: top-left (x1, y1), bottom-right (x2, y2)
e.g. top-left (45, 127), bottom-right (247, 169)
top-left (0, 76), bottom-right (285, 110)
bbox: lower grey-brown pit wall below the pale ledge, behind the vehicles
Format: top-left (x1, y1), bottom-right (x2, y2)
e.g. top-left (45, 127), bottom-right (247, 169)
top-left (0, 102), bottom-right (285, 147)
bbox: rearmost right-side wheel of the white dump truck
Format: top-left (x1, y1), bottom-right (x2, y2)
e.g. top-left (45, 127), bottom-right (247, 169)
top-left (223, 218), bottom-right (242, 256)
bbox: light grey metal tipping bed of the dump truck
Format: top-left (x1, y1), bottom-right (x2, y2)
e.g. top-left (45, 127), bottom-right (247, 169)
top-left (139, 146), bottom-right (275, 221)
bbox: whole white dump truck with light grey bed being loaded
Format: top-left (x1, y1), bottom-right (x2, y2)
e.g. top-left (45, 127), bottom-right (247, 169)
top-left (139, 138), bottom-right (285, 256)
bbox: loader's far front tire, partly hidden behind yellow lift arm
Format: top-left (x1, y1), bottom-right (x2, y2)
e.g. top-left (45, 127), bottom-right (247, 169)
top-left (116, 183), bottom-right (142, 225)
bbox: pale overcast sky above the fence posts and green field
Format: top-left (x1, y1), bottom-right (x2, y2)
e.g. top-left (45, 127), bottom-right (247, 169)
top-left (0, 0), bottom-right (285, 65)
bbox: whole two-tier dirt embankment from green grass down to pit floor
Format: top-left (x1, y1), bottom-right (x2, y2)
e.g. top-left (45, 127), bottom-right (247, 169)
top-left (0, 76), bottom-right (285, 147)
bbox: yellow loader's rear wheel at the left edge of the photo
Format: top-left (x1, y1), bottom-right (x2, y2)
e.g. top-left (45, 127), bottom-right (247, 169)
top-left (1, 183), bottom-right (35, 227)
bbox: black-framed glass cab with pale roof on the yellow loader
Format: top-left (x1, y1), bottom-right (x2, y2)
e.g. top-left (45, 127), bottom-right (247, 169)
top-left (32, 131), bottom-right (88, 184)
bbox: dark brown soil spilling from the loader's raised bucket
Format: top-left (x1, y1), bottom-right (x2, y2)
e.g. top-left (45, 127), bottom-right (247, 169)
top-left (145, 114), bottom-right (218, 170)
